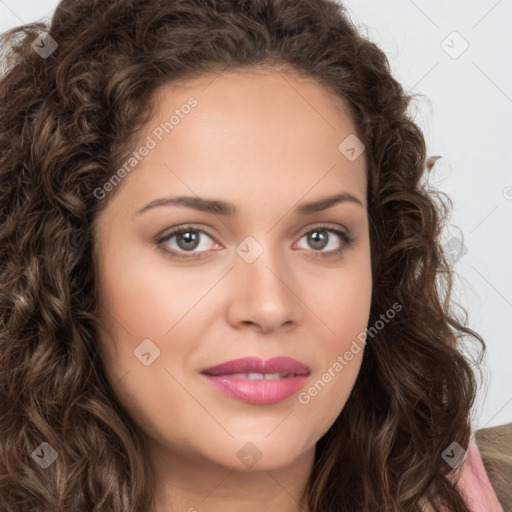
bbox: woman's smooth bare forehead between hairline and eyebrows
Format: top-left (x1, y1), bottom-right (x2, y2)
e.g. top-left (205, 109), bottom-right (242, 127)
top-left (102, 65), bottom-right (366, 214)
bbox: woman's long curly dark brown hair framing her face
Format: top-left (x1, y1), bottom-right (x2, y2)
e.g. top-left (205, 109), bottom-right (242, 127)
top-left (0, 0), bottom-right (486, 512)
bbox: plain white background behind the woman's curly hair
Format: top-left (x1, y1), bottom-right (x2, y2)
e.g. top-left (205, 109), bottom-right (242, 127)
top-left (0, 0), bottom-right (512, 428)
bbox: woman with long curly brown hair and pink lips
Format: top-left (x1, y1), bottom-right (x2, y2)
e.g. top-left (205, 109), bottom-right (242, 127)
top-left (0, 0), bottom-right (510, 512)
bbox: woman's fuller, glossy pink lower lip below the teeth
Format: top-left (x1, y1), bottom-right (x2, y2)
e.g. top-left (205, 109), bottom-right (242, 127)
top-left (205, 375), bottom-right (308, 404)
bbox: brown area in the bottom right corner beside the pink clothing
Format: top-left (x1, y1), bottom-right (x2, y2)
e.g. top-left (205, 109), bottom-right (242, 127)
top-left (475, 423), bottom-right (512, 512)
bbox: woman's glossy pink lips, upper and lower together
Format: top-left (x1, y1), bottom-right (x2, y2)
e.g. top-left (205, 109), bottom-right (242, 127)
top-left (201, 357), bottom-right (310, 404)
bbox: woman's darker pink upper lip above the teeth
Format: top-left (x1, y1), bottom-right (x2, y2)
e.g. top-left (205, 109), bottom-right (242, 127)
top-left (201, 357), bottom-right (309, 375)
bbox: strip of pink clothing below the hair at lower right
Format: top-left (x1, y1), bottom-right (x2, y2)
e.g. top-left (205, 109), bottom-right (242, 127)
top-left (457, 435), bottom-right (503, 512)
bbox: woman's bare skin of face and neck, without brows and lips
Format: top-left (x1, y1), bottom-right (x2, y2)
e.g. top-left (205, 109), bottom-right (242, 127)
top-left (94, 69), bottom-right (372, 512)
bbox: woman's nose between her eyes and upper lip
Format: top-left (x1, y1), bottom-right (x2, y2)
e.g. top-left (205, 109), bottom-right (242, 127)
top-left (228, 242), bottom-right (304, 333)
